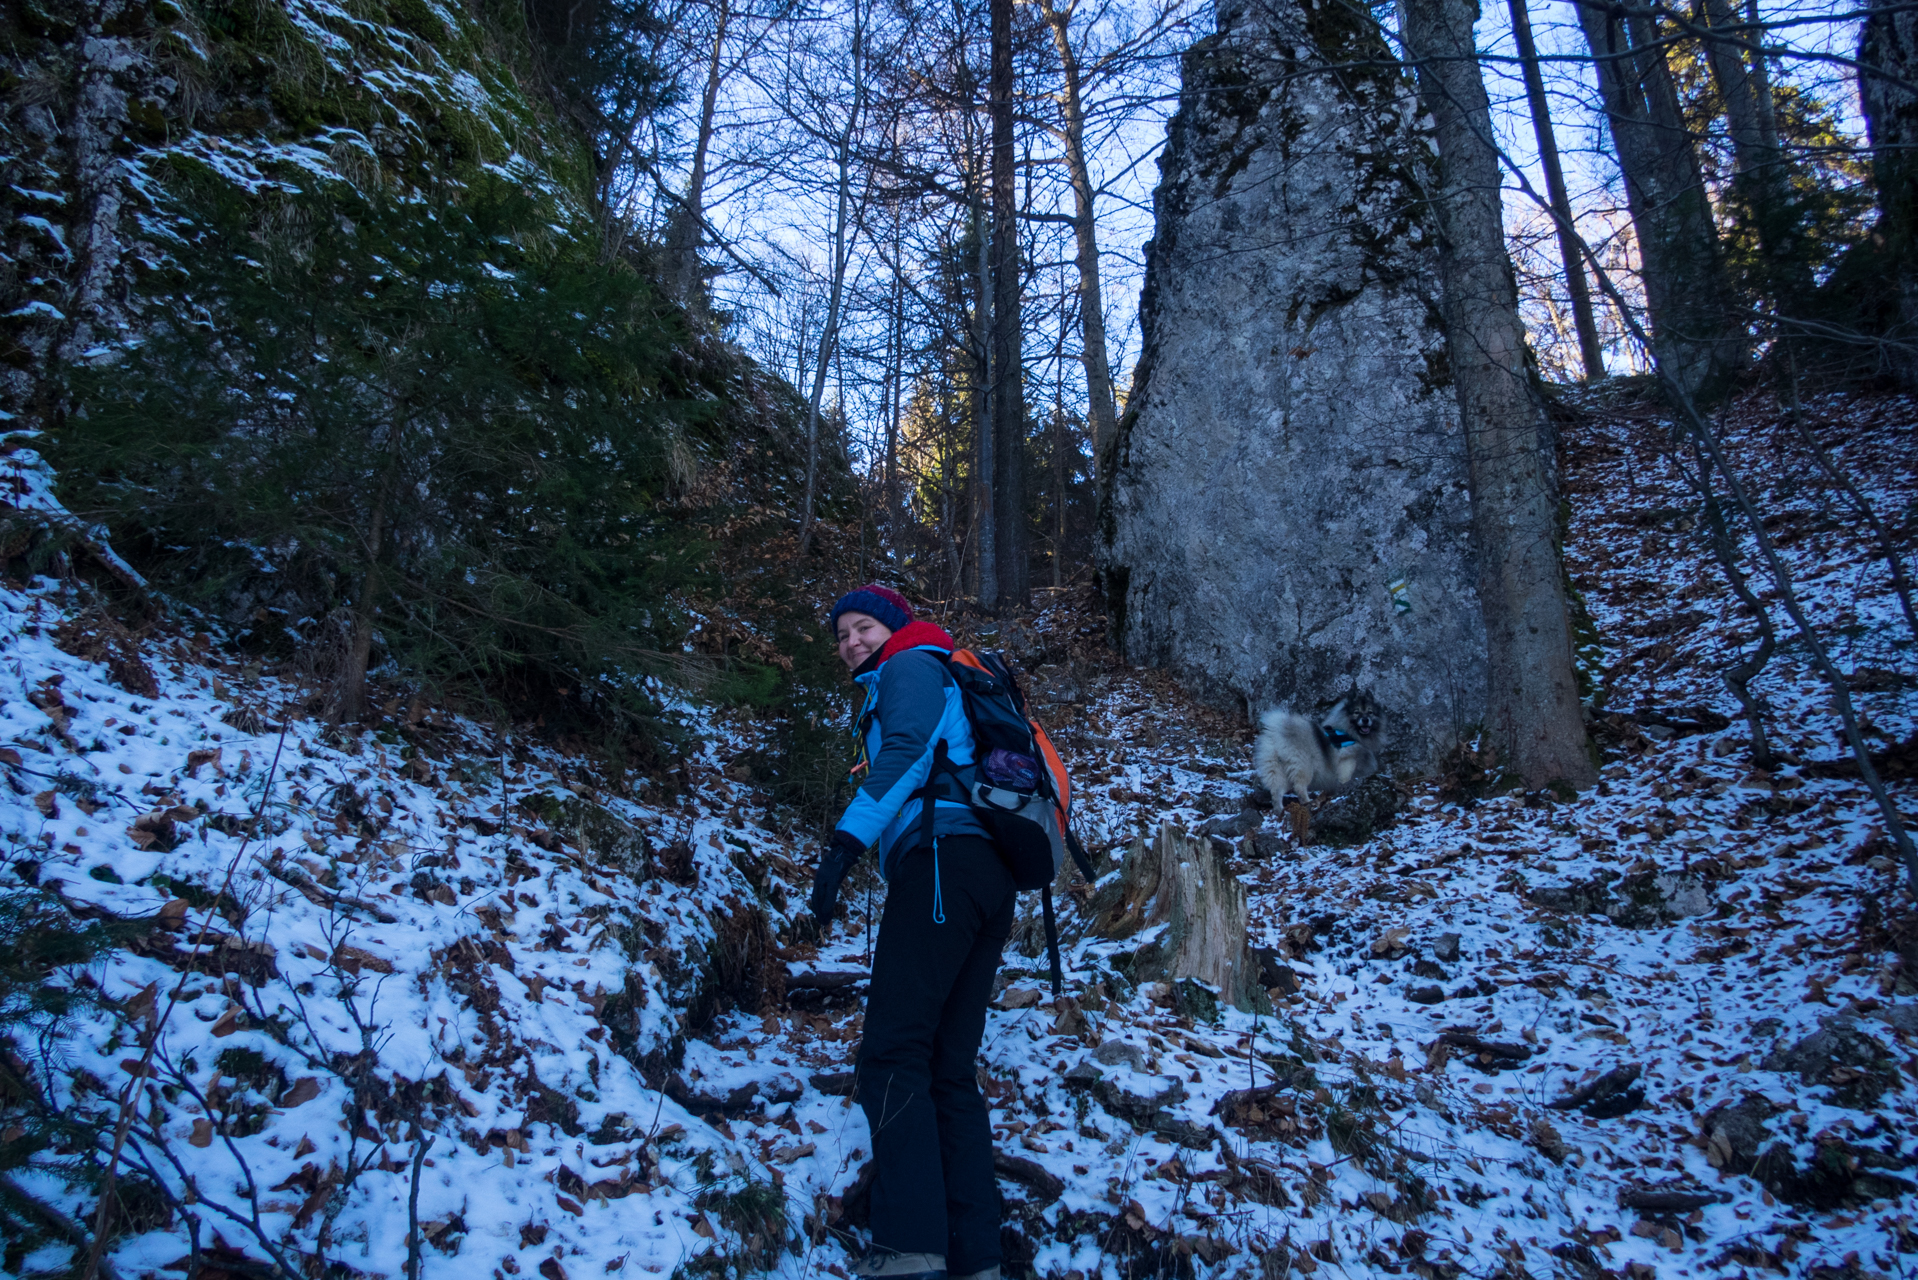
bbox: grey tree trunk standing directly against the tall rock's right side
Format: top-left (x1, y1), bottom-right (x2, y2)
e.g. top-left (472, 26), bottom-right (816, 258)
top-left (1400, 0), bottom-right (1598, 787)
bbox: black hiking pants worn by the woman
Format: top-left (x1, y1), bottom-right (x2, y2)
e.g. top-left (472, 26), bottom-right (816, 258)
top-left (857, 835), bottom-right (1015, 1276)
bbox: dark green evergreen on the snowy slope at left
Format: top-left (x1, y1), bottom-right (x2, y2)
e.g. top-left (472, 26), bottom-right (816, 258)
top-left (56, 175), bottom-right (717, 718)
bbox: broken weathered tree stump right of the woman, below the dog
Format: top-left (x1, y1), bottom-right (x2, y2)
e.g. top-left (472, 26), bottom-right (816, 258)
top-left (1086, 823), bottom-right (1264, 1013)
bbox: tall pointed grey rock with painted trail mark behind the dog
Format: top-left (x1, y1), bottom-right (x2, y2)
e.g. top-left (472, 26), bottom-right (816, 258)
top-left (1103, 0), bottom-right (1485, 766)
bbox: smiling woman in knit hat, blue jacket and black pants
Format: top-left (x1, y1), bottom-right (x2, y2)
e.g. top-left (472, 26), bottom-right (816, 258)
top-left (811, 583), bottom-right (1015, 1280)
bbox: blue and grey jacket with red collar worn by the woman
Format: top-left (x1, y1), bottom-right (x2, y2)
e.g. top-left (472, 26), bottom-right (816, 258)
top-left (838, 622), bottom-right (990, 879)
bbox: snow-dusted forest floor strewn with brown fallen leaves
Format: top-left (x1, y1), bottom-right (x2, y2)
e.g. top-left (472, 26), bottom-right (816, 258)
top-left (0, 399), bottom-right (1918, 1280)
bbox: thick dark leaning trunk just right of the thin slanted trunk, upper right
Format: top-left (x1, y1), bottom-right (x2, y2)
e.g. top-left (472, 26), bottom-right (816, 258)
top-left (1575, 0), bottom-right (1747, 401)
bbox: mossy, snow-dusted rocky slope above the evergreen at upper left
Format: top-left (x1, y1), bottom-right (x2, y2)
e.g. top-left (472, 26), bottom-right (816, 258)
top-left (0, 0), bottom-right (591, 430)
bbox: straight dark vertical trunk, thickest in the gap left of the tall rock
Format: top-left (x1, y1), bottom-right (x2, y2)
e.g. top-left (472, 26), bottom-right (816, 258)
top-left (986, 0), bottom-right (1032, 612)
